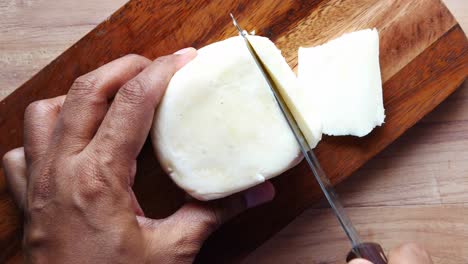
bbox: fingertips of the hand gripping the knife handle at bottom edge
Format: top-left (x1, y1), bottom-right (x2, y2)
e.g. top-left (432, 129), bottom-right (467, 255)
top-left (348, 243), bottom-right (432, 264)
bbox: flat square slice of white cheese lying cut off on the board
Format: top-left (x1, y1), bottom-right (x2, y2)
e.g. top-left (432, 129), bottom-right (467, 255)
top-left (298, 29), bottom-right (385, 137)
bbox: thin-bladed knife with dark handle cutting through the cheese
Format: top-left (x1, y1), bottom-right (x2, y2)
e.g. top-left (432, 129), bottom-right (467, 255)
top-left (230, 14), bottom-right (388, 264)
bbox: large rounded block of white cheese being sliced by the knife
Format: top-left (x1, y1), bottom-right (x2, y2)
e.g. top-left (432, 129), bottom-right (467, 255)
top-left (151, 36), bottom-right (321, 200)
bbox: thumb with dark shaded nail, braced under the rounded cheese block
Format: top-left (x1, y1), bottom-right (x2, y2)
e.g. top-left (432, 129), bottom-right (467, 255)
top-left (138, 181), bottom-right (275, 262)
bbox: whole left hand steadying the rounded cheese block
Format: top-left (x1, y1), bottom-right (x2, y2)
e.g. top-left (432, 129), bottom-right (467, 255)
top-left (3, 48), bottom-right (274, 263)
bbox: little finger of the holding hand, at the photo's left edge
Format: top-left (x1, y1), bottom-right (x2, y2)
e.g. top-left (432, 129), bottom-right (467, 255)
top-left (3, 148), bottom-right (27, 208)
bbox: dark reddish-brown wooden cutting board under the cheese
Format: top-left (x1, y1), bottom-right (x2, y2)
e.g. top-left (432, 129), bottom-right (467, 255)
top-left (0, 0), bottom-right (468, 263)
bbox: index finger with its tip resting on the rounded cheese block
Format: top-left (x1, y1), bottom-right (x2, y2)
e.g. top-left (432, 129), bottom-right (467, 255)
top-left (89, 48), bottom-right (196, 164)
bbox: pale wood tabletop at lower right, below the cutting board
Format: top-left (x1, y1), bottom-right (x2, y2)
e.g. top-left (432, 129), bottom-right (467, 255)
top-left (244, 82), bottom-right (468, 264)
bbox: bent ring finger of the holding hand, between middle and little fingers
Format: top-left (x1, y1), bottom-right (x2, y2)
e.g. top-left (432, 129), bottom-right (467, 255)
top-left (24, 95), bottom-right (65, 164)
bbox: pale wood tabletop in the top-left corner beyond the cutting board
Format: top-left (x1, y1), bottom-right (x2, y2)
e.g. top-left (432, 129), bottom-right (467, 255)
top-left (0, 0), bottom-right (126, 99)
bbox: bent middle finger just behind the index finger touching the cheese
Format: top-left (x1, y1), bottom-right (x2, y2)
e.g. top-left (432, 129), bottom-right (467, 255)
top-left (59, 55), bottom-right (150, 151)
